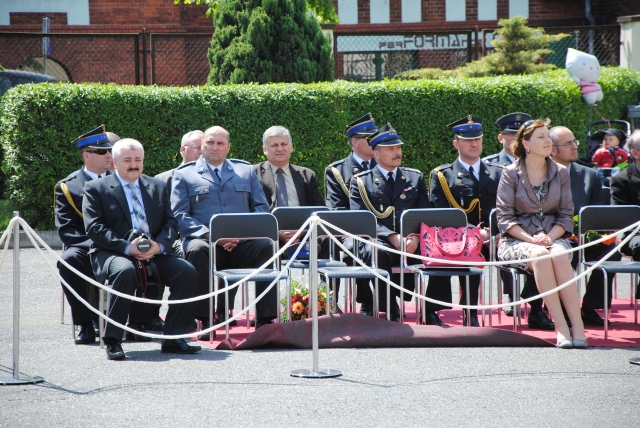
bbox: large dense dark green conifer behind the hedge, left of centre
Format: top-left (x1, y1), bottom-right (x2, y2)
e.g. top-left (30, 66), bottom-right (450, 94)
top-left (208, 0), bottom-right (333, 85)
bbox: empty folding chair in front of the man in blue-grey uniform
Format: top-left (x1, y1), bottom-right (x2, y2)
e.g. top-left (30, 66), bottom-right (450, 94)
top-left (209, 213), bottom-right (288, 342)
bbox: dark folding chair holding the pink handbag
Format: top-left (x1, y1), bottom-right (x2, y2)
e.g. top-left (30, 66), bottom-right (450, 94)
top-left (400, 208), bottom-right (484, 326)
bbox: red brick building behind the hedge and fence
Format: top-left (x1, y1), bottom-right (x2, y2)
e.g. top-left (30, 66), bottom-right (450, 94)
top-left (0, 0), bottom-right (640, 85)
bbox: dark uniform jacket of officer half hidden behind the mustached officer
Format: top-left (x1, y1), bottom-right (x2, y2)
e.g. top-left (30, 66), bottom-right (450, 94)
top-left (324, 153), bottom-right (377, 210)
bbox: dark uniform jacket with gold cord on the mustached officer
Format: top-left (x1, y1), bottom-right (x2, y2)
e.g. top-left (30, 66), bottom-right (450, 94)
top-left (350, 167), bottom-right (431, 238)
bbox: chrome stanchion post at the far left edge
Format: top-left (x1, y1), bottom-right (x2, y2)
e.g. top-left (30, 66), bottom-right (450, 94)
top-left (0, 211), bottom-right (44, 385)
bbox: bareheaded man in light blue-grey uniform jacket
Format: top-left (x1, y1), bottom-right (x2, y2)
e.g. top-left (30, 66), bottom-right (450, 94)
top-left (171, 126), bottom-right (278, 340)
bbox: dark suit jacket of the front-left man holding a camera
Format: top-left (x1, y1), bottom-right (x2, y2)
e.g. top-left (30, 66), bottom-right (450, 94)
top-left (82, 174), bottom-right (178, 282)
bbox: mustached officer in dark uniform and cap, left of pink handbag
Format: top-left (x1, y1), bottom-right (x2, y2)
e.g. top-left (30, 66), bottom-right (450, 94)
top-left (350, 124), bottom-right (430, 321)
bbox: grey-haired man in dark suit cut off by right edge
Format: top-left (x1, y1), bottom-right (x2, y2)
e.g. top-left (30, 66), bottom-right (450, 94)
top-left (610, 130), bottom-right (640, 296)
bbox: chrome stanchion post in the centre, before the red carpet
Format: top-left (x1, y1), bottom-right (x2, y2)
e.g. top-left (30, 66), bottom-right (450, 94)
top-left (289, 217), bottom-right (342, 378)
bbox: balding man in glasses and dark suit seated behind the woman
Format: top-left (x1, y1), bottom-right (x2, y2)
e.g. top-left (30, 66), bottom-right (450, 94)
top-left (552, 126), bottom-right (622, 326)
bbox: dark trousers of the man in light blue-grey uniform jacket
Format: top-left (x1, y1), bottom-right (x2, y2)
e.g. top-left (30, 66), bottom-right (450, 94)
top-left (185, 239), bottom-right (278, 320)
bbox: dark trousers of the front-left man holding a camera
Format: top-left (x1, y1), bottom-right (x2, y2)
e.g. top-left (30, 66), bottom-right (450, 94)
top-left (104, 254), bottom-right (196, 340)
